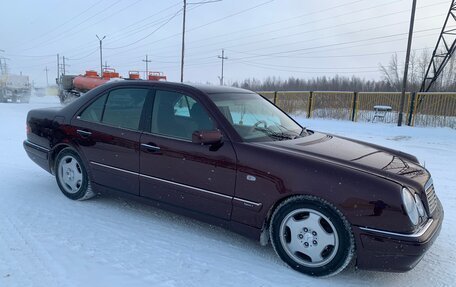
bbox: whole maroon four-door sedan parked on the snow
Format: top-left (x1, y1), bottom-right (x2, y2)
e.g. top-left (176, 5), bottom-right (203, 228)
top-left (24, 81), bottom-right (443, 276)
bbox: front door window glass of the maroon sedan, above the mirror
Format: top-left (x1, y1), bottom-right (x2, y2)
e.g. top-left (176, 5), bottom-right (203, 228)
top-left (151, 90), bottom-right (215, 140)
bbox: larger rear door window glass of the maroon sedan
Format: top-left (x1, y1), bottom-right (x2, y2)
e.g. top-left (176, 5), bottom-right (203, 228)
top-left (101, 88), bottom-right (149, 130)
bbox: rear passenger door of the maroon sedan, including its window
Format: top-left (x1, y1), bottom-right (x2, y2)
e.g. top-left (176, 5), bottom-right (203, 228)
top-left (72, 88), bottom-right (150, 194)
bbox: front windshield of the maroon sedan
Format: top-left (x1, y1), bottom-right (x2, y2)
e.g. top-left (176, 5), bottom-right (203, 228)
top-left (210, 93), bottom-right (305, 141)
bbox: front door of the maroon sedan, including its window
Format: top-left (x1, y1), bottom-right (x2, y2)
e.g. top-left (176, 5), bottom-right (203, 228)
top-left (140, 90), bottom-right (236, 219)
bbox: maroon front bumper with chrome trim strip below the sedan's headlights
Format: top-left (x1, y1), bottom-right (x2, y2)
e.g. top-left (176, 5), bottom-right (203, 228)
top-left (353, 200), bottom-right (444, 272)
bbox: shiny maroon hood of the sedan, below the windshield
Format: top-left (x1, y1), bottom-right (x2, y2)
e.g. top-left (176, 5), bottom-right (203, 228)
top-left (261, 132), bottom-right (430, 187)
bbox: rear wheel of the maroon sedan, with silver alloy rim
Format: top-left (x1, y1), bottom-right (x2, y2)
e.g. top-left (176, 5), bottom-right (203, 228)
top-left (55, 148), bottom-right (95, 200)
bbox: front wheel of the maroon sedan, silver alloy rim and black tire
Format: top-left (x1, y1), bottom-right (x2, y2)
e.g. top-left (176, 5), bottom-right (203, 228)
top-left (269, 196), bottom-right (355, 277)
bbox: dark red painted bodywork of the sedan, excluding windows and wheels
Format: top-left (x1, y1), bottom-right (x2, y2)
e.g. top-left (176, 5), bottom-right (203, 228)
top-left (24, 81), bottom-right (443, 271)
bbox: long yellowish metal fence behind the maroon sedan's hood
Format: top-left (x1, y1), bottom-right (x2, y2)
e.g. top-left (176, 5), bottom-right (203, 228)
top-left (259, 91), bottom-right (456, 128)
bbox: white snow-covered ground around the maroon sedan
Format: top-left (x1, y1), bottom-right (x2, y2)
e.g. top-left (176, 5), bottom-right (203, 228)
top-left (0, 96), bottom-right (456, 287)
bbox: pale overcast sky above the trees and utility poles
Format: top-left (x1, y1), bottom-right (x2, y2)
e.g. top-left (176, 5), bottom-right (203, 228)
top-left (0, 0), bottom-right (451, 85)
